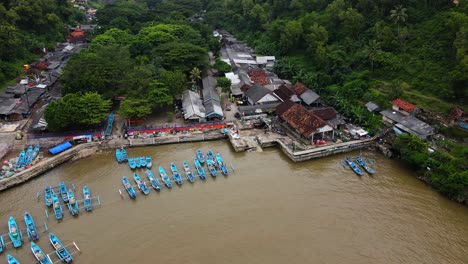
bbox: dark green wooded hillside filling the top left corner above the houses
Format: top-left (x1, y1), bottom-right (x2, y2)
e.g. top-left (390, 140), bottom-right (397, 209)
top-left (0, 0), bottom-right (84, 86)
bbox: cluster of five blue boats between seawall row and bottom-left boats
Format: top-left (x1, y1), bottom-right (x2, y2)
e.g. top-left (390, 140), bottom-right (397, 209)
top-left (44, 182), bottom-right (100, 219)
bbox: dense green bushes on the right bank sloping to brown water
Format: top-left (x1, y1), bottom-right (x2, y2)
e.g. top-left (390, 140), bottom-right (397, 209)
top-left (393, 133), bottom-right (468, 201)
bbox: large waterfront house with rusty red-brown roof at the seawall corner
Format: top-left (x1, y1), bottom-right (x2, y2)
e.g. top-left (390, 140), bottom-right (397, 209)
top-left (276, 100), bottom-right (334, 143)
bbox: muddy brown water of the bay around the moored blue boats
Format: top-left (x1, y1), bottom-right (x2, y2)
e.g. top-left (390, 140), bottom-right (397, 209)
top-left (0, 141), bottom-right (468, 264)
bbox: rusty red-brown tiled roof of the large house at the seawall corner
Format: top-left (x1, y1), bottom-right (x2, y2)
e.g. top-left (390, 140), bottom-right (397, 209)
top-left (276, 101), bottom-right (326, 138)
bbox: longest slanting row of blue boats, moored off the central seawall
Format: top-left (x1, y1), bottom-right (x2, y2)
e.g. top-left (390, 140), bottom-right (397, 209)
top-left (119, 150), bottom-right (229, 198)
